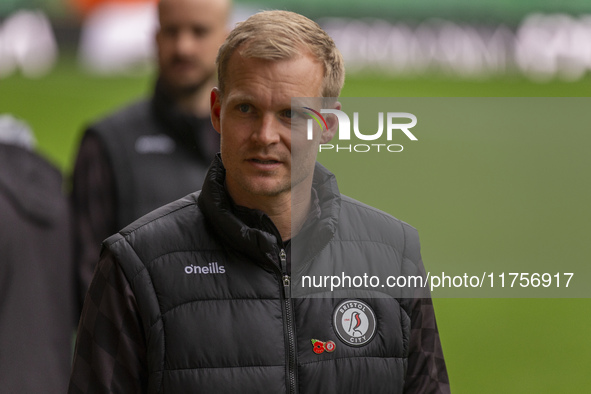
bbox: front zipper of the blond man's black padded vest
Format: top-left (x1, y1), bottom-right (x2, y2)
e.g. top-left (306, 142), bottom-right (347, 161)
top-left (279, 249), bottom-right (297, 394)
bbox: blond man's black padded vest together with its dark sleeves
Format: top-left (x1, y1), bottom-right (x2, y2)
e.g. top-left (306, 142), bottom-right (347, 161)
top-left (70, 157), bottom-right (449, 394)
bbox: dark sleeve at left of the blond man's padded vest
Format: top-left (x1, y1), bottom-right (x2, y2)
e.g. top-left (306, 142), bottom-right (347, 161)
top-left (68, 251), bottom-right (147, 394)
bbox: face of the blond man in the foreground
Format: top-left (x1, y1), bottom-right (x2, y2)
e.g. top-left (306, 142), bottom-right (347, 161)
top-left (211, 51), bottom-right (331, 205)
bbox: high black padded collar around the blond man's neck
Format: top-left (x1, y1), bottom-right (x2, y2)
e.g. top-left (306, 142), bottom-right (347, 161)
top-left (197, 154), bottom-right (341, 269)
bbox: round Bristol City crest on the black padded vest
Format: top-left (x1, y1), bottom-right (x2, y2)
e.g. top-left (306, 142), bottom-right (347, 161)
top-left (333, 300), bottom-right (376, 346)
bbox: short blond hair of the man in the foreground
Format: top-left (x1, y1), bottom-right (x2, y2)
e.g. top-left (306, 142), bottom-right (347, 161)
top-left (216, 11), bottom-right (345, 97)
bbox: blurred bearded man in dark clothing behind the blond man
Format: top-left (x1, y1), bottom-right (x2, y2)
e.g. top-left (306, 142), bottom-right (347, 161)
top-left (72, 0), bottom-right (231, 299)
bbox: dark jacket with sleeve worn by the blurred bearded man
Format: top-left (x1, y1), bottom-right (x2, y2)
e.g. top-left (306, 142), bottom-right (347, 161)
top-left (72, 82), bottom-right (219, 302)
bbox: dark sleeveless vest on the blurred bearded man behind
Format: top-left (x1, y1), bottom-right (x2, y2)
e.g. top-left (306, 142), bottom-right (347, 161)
top-left (86, 94), bottom-right (219, 229)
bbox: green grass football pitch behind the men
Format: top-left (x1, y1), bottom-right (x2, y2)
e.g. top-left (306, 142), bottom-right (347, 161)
top-left (0, 57), bottom-right (591, 394)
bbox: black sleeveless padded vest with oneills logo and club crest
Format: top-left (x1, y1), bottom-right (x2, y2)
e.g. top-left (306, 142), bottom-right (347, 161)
top-left (105, 157), bottom-right (423, 394)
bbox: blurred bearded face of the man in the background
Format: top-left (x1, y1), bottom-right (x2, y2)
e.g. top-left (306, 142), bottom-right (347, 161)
top-left (156, 0), bottom-right (229, 95)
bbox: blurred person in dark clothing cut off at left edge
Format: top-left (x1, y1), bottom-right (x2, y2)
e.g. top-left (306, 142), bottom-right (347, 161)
top-left (0, 115), bottom-right (77, 394)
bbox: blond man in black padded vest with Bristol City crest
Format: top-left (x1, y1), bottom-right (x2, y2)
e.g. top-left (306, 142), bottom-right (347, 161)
top-left (70, 11), bottom-right (449, 393)
